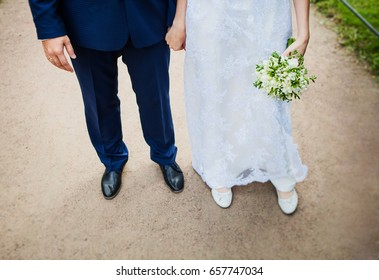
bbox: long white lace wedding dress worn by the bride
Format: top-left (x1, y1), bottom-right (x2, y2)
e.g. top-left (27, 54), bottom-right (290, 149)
top-left (184, 0), bottom-right (307, 188)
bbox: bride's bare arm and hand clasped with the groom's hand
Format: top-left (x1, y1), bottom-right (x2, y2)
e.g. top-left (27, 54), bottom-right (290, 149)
top-left (166, 0), bottom-right (187, 51)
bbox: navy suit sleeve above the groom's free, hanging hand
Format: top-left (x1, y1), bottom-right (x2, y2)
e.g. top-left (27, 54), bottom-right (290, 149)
top-left (29, 0), bottom-right (67, 40)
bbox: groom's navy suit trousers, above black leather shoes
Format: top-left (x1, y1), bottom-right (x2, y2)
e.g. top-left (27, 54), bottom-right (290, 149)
top-left (72, 39), bottom-right (177, 171)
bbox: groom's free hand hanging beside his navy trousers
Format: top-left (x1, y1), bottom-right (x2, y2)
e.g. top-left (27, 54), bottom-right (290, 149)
top-left (42, 36), bottom-right (76, 72)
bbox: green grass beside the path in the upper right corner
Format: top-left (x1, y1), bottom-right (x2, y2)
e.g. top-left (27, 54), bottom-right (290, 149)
top-left (311, 0), bottom-right (379, 76)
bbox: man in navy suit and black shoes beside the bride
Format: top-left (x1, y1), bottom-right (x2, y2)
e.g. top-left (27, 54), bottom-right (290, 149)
top-left (29, 0), bottom-right (184, 199)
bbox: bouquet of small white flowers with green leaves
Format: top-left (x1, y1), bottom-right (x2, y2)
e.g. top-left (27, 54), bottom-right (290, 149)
top-left (254, 40), bottom-right (316, 102)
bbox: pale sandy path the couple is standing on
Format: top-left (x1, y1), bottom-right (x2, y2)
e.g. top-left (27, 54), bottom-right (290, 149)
top-left (0, 0), bottom-right (379, 259)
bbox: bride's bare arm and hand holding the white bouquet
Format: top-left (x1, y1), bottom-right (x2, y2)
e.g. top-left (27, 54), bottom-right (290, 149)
top-left (283, 0), bottom-right (310, 55)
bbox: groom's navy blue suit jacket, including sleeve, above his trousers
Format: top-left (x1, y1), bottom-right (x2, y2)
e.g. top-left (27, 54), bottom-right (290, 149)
top-left (29, 0), bottom-right (176, 51)
